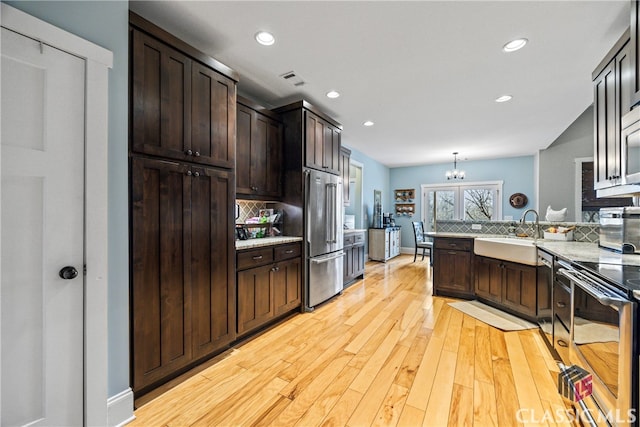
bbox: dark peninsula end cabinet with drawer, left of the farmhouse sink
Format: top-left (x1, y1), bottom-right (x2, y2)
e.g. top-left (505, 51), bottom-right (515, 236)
top-left (433, 237), bottom-right (474, 298)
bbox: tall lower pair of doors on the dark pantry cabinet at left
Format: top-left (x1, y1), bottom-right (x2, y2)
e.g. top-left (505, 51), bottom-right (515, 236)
top-left (131, 156), bottom-right (235, 392)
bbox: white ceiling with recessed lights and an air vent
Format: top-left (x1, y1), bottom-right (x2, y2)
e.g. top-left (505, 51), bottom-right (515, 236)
top-left (130, 0), bottom-right (629, 167)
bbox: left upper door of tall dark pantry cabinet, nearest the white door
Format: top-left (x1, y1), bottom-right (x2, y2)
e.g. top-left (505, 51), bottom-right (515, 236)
top-left (131, 30), bottom-right (192, 160)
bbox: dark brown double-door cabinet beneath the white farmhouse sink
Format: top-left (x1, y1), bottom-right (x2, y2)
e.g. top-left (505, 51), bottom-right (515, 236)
top-left (474, 256), bottom-right (550, 319)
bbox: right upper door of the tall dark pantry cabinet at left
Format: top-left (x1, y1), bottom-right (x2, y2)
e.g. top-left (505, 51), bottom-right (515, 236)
top-left (190, 62), bottom-right (236, 168)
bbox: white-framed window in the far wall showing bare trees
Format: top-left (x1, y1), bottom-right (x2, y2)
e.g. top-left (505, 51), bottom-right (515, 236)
top-left (421, 181), bottom-right (503, 231)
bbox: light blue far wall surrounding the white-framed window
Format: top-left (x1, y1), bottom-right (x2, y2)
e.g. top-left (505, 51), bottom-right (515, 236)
top-left (390, 156), bottom-right (537, 247)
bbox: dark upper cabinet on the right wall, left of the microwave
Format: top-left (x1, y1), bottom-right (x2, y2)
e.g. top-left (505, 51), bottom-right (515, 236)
top-left (593, 33), bottom-right (634, 190)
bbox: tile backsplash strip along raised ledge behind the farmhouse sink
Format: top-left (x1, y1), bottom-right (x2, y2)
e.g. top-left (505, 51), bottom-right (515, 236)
top-left (436, 221), bottom-right (599, 243)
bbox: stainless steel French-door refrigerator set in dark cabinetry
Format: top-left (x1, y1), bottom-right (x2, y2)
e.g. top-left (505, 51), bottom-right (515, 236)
top-left (305, 169), bottom-right (344, 309)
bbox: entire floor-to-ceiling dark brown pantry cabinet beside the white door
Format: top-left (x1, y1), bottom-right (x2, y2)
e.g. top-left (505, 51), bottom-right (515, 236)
top-left (129, 12), bottom-right (237, 397)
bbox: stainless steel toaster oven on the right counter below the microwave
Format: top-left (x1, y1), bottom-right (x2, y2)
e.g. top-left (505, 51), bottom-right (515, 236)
top-left (599, 206), bottom-right (640, 255)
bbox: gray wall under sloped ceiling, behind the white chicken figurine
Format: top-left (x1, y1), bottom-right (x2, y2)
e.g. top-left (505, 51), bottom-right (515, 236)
top-left (538, 106), bottom-right (593, 221)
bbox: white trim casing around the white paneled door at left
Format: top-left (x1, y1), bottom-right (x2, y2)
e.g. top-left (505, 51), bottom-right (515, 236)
top-left (1, 3), bottom-right (117, 426)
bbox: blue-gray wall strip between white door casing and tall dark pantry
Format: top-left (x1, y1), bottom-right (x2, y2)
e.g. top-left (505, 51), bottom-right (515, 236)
top-left (6, 0), bottom-right (129, 396)
